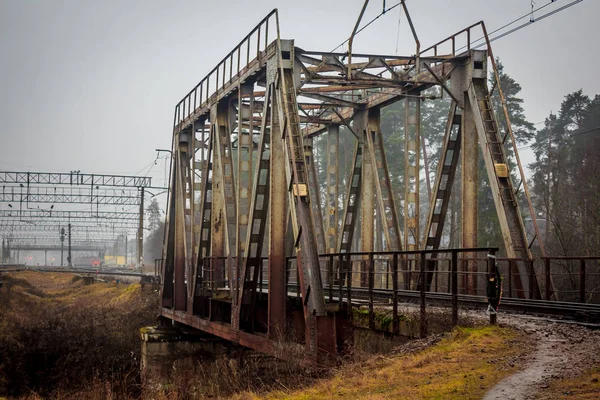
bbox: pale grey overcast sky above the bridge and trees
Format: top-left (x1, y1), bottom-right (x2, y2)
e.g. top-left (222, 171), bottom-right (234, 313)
top-left (0, 0), bottom-right (600, 203)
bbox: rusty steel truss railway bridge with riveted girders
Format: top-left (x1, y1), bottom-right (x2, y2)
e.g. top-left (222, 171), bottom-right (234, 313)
top-left (160, 7), bottom-right (588, 362)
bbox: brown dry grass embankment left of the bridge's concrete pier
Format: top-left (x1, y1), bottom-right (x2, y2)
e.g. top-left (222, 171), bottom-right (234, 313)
top-left (0, 271), bottom-right (156, 398)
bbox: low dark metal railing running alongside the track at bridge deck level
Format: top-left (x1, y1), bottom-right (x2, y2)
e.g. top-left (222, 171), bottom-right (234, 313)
top-left (197, 252), bottom-right (600, 304)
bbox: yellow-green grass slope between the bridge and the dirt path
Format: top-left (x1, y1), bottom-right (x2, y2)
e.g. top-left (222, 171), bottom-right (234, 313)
top-left (227, 326), bottom-right (525, 399)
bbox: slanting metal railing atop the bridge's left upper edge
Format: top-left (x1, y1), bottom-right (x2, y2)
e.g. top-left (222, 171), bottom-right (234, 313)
top-left (173, 9), bottom-right (279, 127)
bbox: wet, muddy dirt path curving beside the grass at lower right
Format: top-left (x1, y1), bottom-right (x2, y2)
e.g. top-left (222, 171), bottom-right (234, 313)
top-left (484, 316), bottom-right (600, 400)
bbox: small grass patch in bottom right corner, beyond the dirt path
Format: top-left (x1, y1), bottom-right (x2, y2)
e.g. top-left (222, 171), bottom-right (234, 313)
top-left (538, 366), bottom-right (600, 400)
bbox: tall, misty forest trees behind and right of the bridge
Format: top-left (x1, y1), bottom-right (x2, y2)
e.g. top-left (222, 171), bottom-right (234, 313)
top-left (313, 60), bottom-right (600, 255)
